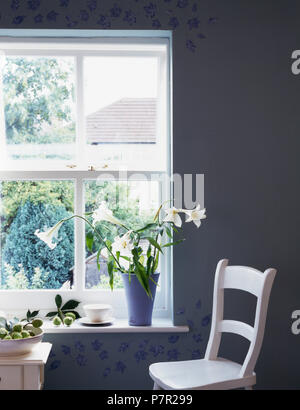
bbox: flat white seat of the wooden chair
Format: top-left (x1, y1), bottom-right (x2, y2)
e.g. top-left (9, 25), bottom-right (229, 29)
top-left (149, 358), bottom-right (256, 390)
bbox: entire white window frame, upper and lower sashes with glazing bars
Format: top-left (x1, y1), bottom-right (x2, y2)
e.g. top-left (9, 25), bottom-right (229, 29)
top-left (0, 30), bottom-right (172, 318)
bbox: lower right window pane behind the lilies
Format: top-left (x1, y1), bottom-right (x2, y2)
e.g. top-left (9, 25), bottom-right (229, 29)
top-left (85, 181), bottom-right (160, 290)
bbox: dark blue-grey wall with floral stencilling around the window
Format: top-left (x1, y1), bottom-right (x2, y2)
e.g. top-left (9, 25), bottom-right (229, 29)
top-left (0, 0), bottom-right (300, 389)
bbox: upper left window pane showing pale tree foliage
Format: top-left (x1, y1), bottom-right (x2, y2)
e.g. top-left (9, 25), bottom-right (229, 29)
top-left (2, 56), bottom-right (76, 160)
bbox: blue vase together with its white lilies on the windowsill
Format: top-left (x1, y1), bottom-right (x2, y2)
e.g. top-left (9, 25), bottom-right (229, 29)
top-left (35, 201), bottom-right (206, 326)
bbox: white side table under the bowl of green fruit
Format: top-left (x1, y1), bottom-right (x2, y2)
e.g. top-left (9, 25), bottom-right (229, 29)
top-left (0, 343), bottom-right (52, 390)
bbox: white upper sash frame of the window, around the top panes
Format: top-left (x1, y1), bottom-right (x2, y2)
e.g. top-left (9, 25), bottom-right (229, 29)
top-left (0, 38), bottom-right (170, 171)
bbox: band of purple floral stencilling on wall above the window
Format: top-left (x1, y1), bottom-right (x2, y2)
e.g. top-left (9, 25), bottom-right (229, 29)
top-left (0, 0), bottom-right (218, 53)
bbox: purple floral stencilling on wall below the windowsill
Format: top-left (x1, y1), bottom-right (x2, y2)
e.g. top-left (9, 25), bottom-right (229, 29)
top-left (46, 300), bottom-right (211, 388)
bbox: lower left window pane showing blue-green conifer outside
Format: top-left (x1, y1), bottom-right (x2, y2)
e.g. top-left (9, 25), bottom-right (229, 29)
top-left (0, 181), bottom-right (74, 289)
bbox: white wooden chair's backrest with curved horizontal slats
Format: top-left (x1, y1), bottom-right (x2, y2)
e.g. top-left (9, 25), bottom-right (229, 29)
top-left (205, 259), bottom-right (276, 377)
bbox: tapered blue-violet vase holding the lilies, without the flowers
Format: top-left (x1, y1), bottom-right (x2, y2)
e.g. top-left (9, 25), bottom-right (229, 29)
top-left (122, 273), bottom-right (159, 326)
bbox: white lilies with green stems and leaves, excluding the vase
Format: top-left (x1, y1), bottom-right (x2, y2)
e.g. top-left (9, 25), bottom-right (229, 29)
top-left (37, 201), bottom-right (206, 298)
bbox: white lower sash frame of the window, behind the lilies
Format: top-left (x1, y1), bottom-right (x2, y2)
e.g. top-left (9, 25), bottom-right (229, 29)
top-left (0, 170), bottom-right (172, 317)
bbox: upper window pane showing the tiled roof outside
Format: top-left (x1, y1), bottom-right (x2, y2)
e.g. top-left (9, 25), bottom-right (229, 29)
top-left (84, 57), bottom-right (164, 169)
